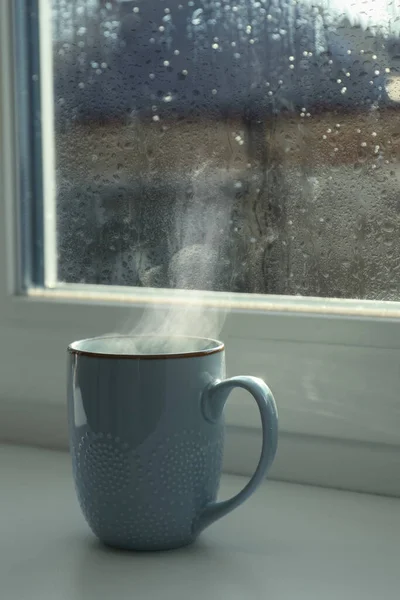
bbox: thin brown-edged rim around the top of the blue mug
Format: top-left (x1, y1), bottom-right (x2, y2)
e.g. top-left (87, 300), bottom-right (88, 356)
top-left (67, 335), bottom-right (225, 360)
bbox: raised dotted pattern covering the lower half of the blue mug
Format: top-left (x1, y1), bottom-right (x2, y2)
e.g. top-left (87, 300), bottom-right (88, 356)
top-left (73, 431), bottom-right (223, 549)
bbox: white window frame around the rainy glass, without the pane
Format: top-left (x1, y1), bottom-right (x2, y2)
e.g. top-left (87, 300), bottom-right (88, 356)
top-left (0, 0), bottom-right (400, 495)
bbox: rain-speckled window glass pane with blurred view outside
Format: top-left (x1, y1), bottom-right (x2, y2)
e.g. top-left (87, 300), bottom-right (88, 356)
top-left (52, 0), bottom-right (400, 300)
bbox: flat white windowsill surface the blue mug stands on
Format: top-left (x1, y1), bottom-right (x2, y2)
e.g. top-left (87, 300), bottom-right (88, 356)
top-left (0, 446), bottom-right (400, 600)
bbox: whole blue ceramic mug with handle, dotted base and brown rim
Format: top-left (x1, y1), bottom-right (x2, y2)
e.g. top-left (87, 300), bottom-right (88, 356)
top-left (68, 336), bottom-right (278, 550)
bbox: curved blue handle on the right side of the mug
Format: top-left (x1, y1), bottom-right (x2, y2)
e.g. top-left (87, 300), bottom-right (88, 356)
top-left (195, 375), bottom-right (278, 533)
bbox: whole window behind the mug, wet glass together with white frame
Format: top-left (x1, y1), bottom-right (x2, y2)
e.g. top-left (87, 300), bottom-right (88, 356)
top-left (0, 0), bottom-right (400, 493)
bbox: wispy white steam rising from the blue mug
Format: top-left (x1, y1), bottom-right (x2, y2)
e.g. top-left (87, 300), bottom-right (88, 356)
top-left (115, 165), bottom-right (233, 353)
